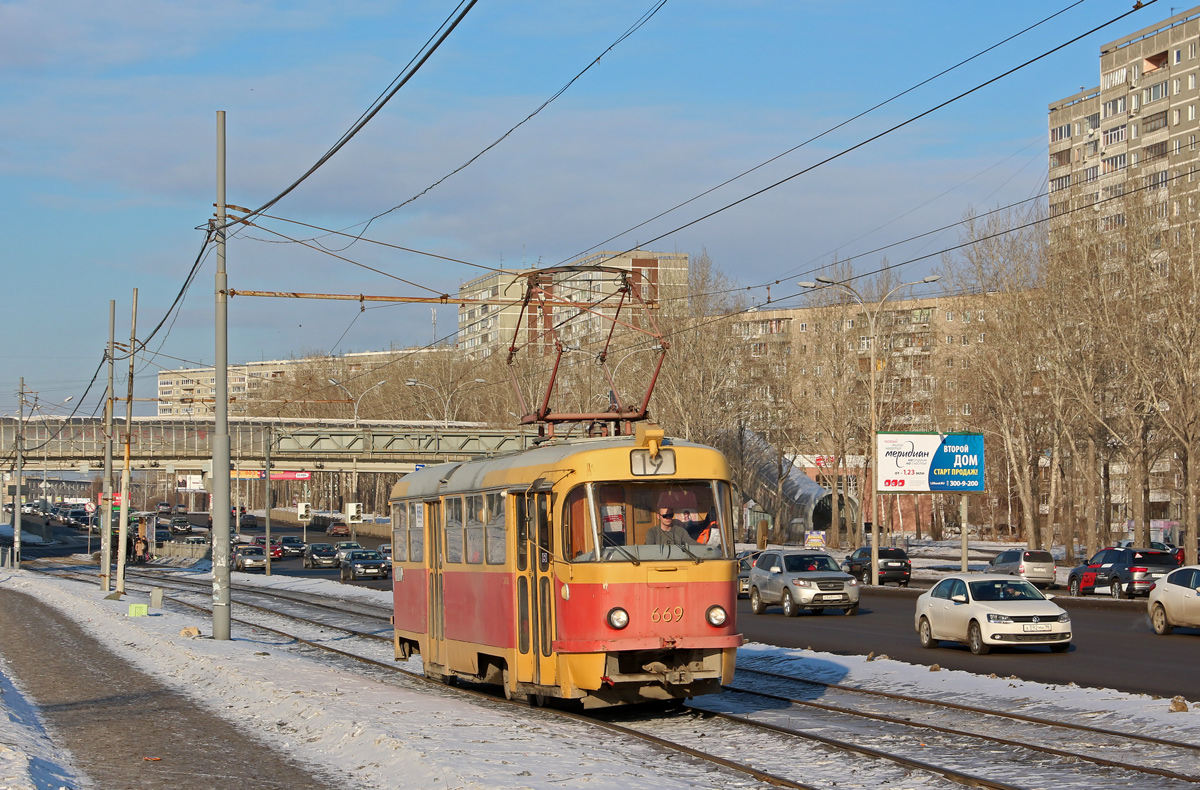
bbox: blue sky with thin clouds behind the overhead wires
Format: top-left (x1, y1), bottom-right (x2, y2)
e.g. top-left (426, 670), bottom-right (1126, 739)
top-left (0, 0), bottom-right (1183, 414)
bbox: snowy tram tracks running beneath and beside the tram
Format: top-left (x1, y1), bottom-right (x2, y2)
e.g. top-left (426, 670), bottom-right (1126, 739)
top-left (28, 559), bottom-right (1200, 790)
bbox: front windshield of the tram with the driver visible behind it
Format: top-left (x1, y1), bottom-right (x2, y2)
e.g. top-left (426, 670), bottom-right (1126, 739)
top-left (563, 480), bottom-right (733, 563)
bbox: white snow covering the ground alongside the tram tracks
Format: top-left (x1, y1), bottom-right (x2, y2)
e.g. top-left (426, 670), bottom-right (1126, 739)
top-left (0, 554), bottom-right (1196, 790)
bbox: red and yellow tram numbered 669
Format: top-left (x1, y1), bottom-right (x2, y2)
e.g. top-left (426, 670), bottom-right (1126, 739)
top-left (391, 424), bottom-right (742, 707)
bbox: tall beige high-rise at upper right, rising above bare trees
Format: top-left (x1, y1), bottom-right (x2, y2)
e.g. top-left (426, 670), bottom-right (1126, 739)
top-left (1049, 6), bottom-right (1200, 240)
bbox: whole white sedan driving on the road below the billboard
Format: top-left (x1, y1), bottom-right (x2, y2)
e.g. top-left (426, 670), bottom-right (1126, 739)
top-left (913, 574), bottom-right (1073, 656)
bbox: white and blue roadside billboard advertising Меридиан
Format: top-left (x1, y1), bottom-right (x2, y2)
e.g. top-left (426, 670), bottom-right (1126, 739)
top-left (875, 433), bottom-right (986, 493)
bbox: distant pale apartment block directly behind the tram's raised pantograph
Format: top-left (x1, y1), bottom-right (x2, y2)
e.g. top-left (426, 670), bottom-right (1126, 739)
top-left (457, 250), bottom-right (688, 358)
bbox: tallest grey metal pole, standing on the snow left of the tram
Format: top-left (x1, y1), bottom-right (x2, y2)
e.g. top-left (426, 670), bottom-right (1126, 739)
top-left (211, 110), bottom-right (232, 640)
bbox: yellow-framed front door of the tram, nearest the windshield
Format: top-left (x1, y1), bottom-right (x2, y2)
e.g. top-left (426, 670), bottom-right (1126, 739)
top-left (517, 491), bottom-right (557, 684)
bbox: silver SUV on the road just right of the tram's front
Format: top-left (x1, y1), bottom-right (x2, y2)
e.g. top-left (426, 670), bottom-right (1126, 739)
top-left (750, 550), bottom-right (858, 617)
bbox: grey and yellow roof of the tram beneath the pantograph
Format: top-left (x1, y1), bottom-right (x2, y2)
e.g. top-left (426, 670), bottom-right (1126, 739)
top-left (392, 436), bottom-right (719, 497)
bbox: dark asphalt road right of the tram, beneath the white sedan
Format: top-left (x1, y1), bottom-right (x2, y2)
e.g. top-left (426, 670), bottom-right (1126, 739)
top-left (738, 587), bottom-right (1200, 699)
